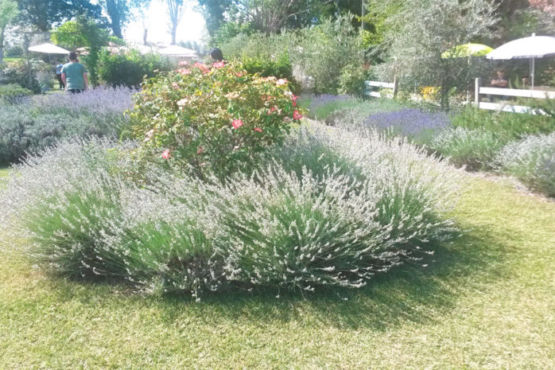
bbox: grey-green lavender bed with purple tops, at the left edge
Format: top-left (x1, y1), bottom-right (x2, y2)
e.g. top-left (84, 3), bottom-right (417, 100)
top-left (0, 88), bottom-right (133, 165)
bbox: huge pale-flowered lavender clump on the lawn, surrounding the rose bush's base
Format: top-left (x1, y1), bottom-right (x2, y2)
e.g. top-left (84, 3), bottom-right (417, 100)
top-left (0, 125), bottom-right (458, 296)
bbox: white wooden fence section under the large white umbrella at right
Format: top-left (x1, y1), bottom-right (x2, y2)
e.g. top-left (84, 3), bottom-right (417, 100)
top-left (474, 78), bottom-right (555, 114)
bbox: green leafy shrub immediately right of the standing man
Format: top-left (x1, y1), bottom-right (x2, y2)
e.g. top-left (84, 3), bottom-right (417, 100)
top-left (98, 51), bottom-right (171, 88)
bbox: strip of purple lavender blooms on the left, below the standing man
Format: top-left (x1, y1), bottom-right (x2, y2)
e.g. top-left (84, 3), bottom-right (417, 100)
top-left (32, 87), bottom-right (136, 115)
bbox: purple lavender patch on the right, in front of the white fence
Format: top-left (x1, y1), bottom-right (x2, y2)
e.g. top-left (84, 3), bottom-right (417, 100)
top-left (364, 108), bottom-right (451, 136)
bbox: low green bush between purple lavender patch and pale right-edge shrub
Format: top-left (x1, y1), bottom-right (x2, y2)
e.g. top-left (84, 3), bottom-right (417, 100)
top-left (429, 127), bottom-right (506, 170)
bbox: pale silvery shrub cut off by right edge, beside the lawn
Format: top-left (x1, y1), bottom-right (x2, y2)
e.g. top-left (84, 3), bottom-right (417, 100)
top-left (495, 133), bottom-right (555, 197)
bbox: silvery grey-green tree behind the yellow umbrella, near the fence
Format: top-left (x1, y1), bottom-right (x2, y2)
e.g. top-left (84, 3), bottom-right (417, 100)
top-left (376, 0), bottom-right (498, 108)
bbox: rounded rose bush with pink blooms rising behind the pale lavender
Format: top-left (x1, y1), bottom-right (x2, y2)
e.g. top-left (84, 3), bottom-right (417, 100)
top-left (131, 62), bottom-right (301, 175)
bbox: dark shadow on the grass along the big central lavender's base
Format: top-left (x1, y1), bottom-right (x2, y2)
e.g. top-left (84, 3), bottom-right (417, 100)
top-left (47, 223), bottom-right (506, 330)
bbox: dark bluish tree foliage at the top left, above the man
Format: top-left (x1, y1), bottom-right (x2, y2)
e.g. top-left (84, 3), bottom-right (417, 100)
top-left (17, 0), bottom-right (102, 32)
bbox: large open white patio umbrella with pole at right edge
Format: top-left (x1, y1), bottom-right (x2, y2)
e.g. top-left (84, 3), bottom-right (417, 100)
top-left (486, 34), bottom-right (555, 89)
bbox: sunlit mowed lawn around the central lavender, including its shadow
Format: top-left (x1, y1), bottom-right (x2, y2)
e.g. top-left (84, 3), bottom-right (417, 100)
top-left (0, 171), bottom-right (555, 369)
